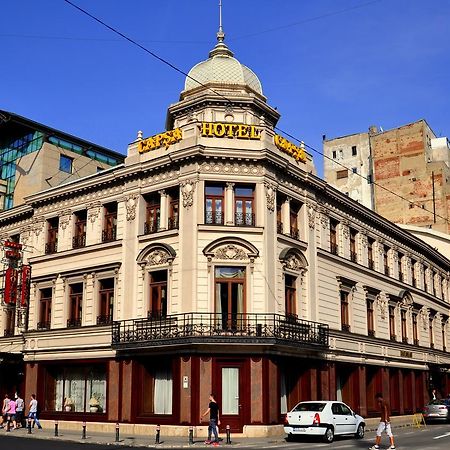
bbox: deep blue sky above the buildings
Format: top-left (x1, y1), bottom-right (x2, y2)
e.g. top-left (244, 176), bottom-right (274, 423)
top-left (0, 0), bottom-right (450, 174)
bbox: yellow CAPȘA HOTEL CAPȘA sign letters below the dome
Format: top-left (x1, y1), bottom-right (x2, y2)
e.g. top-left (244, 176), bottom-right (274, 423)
top-left (139, 122), bottom-right (306, 162)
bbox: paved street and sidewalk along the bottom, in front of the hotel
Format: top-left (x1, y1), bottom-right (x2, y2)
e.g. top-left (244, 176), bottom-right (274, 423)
top-left (0, 424), bottom-right (450, 450)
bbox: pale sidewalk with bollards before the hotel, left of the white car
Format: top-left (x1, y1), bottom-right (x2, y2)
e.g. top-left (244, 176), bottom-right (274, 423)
top-left (0, 427), bottom-right (286, 449)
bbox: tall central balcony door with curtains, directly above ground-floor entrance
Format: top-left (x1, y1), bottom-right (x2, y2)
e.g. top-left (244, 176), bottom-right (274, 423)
top-left (214, 267), bottom-right (245, 330)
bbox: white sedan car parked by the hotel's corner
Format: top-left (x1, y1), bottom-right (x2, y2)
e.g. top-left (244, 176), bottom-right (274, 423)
top-left (284, 400), bottom-right (366, 443)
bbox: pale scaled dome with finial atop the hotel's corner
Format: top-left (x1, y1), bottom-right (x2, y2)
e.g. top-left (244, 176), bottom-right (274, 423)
top-left (184, 31), bottom-right (262, 95)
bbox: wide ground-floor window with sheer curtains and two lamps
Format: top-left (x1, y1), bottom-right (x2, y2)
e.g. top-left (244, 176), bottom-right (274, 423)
top-left (44, 365), bottom-right (106, 414)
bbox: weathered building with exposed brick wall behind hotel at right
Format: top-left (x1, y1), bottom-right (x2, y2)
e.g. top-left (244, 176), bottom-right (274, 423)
top-left (323, 120), bottom-right (450, 233)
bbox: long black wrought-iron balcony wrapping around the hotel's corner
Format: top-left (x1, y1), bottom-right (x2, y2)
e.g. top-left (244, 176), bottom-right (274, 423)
top-left (112, 312), bottom-right (329, 350)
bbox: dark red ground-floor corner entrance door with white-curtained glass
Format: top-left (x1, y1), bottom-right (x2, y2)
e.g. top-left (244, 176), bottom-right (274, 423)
top-left (213, 359), bottom-right (251, 433)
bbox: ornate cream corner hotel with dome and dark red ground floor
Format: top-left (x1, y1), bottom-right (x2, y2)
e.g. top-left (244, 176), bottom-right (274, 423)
top-left (0, 33), bottom-right (450, 434)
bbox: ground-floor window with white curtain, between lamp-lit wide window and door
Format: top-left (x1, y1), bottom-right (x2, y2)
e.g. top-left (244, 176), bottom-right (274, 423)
top-left (141, 360), bottom-right (173, 415)
